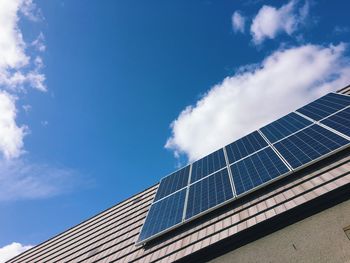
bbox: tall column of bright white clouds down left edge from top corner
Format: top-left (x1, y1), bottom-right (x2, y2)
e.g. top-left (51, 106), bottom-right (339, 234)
top-left (0, 0), bottom-right (46, 159)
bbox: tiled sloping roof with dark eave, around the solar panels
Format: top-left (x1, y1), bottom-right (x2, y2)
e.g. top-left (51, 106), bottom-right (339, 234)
top-left (8, 86), bottom-right (350, 262)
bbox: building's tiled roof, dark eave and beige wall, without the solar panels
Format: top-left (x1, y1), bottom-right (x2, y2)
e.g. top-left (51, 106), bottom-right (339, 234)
top-left (8, 86), bottom-right (350, 263)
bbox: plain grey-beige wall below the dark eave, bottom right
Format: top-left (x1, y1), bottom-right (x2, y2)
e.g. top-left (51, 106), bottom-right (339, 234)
top-left (212, 200), bottom-right (350, 263)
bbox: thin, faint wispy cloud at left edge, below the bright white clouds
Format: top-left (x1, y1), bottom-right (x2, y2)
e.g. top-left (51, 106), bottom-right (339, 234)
top-left (0, 159), bottom-right (79, 202)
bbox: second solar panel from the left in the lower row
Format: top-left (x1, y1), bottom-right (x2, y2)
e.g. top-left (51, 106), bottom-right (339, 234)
top-left (186, 169), bottom-right (233, 219)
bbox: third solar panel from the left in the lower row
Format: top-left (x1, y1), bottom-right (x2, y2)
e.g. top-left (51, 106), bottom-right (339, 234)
top-left (231, 147), bottom-right (290, 195)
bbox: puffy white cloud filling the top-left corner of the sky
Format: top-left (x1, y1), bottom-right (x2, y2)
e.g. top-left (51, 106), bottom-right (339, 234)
top-left (0, 0), bottom-right (46, 91)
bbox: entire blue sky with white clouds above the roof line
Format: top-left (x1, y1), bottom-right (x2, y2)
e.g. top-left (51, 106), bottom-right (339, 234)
top-left (0, 0), bottom-right (350, 261)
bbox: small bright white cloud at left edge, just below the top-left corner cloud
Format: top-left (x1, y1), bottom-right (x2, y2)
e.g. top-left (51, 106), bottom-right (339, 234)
top-left (0, 90), bottom-right (28, 159)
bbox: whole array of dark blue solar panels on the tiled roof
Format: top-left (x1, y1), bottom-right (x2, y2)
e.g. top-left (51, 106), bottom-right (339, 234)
top-left (137, 93), bottom-right (350, 244)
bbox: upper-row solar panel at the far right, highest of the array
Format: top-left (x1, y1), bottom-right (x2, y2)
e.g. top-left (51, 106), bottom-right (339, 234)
top-left (297, 93), bottom-right (350, 121)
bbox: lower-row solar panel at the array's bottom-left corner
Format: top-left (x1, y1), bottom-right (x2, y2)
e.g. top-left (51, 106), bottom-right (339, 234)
top-left (138, 188), bottom-right (187, 242)
